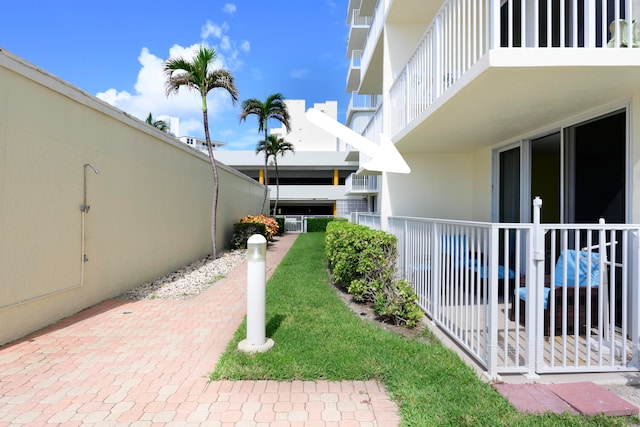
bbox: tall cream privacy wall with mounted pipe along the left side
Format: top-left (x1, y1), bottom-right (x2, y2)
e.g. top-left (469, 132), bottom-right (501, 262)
top-left (0, 50), bottom-right (263, 344)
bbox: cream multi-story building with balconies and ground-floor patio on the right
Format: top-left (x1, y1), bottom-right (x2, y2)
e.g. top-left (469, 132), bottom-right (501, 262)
top-left (346, 0), bottom-right (640, 375)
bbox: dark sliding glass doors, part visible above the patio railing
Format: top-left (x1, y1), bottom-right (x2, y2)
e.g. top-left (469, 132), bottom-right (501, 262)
top-left (496, 110), bottom-right (627, 223)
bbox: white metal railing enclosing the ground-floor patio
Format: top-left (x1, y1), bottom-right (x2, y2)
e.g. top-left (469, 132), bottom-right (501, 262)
top-left (357, 201), bottom-right (640, 377)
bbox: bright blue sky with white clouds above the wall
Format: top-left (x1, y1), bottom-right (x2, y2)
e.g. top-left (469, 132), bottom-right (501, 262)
top-left (0, 0), bottom-right (349, 150)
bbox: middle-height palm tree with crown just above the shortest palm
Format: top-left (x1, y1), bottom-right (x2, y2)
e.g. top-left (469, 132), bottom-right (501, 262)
top-left (240, 93), bottom-right (291, 213)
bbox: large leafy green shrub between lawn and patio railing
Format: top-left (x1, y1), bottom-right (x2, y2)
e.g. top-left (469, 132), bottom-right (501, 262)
top-left (325, 222), bottom-right (423, 327)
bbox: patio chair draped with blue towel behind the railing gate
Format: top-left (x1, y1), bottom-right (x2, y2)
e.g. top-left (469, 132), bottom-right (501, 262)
top-left (510, 249), bottom-right (606, 336)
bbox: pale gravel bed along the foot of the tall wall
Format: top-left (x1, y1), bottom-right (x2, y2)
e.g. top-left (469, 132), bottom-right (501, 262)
top-left (120, 249), bottom-right (247, 300)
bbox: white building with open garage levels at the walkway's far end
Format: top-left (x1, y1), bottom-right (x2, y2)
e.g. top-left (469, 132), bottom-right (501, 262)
top-left (216, 100), bottom-right (377, 217)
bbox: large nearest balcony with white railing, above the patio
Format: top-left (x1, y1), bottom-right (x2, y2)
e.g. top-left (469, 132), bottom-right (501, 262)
top-left (388, 0), bottom-right (640, 151)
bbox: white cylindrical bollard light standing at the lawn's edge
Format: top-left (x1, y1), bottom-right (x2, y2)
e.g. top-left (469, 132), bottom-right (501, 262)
top-left (238, 234), bottom-right (274, 353)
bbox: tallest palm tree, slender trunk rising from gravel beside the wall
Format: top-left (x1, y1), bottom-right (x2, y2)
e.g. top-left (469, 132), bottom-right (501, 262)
top-left (164, 46), bottom-right (239, 259)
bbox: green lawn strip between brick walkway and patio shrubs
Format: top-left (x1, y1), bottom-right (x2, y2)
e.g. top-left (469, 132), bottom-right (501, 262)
top-left (211, 233), bottom-right (629, 426)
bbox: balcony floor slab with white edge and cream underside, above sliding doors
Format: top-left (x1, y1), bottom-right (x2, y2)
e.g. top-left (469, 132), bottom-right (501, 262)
top-left (393, 48), bottom-right (640, 153)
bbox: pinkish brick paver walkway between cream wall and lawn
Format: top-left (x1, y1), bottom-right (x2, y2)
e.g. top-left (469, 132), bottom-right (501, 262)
top-left (0, 234), bottom-right (399, 427)
